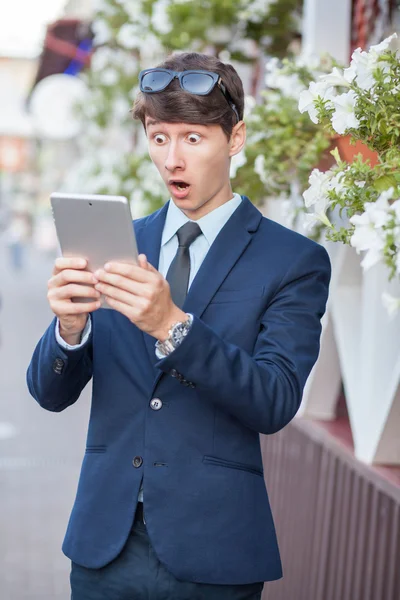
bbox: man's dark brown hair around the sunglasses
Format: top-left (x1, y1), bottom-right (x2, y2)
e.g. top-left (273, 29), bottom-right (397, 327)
top-left (132, 52), bottom-right (244, 140)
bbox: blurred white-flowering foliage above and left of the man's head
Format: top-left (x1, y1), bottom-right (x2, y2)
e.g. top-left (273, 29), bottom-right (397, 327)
top-left (66, 0), bottom-right (302, 214)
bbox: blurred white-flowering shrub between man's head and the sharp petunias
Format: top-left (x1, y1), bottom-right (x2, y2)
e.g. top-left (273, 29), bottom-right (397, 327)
top-left (234, 58), bottom-right (332, 237)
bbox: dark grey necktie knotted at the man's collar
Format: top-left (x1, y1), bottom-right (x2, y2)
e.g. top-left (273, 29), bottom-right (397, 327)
top-left (166, 221), bottom-right (202, 308)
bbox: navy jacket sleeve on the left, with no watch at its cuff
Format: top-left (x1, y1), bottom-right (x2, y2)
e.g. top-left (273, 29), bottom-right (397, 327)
top-left (27, 319), bottom-right (92, 412)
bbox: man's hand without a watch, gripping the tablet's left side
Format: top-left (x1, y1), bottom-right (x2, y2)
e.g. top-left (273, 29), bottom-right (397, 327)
top-left (47, 258), bottom-right (101, 346)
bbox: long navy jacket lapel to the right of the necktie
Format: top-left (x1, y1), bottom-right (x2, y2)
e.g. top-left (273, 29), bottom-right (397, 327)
top-left (183, 196), bottom-right (262, 317)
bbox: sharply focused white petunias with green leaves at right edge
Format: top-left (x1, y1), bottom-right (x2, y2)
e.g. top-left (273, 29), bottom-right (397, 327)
top-left (299, 34), bottom-right (400, 312)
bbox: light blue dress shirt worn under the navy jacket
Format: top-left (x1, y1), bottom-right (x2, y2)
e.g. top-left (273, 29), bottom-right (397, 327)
top-left (56, 194), bottom-right (242, 502)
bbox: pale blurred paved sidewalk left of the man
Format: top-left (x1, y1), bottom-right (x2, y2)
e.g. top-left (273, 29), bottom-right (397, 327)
top-left (0, 240), bottom-right (90, 600)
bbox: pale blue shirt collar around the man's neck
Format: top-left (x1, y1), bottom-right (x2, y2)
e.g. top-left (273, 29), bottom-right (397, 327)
top-left (161, 194), bottom-right (242, 246)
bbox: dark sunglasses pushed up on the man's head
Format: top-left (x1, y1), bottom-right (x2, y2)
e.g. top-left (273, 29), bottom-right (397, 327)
top-left (139, 68), bottom-right (240, 122)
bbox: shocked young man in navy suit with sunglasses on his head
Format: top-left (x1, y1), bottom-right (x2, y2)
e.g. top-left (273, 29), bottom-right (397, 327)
top-left (28, 53), bottom-right (330, 600)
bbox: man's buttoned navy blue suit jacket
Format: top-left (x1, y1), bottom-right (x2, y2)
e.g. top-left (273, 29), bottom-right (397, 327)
top-left (27, 197), bottom-right (330, 584)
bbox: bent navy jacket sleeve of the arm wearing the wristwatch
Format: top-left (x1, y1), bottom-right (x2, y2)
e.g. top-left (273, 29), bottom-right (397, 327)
top-left (156, 244), bottom-right (331, 434)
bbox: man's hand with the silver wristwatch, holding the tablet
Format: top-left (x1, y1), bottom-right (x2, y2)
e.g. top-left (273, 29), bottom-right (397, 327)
top-left (94, 254), bottom-right (187, 342)
